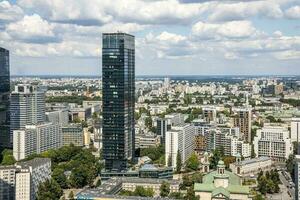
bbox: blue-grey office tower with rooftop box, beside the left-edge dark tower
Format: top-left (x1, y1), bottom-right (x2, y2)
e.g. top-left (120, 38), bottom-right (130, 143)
top-left (10, 84), bottom-right (46, 132)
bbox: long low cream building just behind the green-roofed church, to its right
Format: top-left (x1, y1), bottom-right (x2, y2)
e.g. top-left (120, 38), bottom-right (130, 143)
top-left (230, 155), bottom-right (273, 176)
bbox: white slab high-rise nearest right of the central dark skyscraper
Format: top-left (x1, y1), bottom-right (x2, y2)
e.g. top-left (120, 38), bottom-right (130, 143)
top-left (165, 124), bottom-right (195, 169)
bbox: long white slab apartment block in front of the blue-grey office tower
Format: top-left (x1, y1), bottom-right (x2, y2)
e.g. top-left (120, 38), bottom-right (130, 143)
top-left (13, 122), bottom-right (62, 160)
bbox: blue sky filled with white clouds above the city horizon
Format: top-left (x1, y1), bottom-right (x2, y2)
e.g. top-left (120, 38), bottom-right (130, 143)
top-left (0, 0), bottom-right (300, 75)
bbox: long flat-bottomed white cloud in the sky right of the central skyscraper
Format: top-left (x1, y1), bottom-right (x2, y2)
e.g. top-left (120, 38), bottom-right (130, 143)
top-left (192, 21), bottom-right (256, 39)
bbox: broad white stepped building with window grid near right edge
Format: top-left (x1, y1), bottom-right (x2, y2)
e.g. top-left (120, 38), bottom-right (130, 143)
top-left (253, 126), bottom-right (293, 161)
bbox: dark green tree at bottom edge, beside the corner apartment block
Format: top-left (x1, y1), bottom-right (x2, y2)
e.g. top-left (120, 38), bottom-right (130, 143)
top-left (37, 179), bottom-right (63, 200)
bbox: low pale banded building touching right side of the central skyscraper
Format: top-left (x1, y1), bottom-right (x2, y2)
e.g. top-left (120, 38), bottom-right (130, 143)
top-left (135, 132), bottom-right (160, 149)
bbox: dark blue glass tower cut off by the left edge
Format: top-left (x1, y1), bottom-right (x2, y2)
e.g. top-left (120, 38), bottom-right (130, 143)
top-left (0, 47), bottom-right (12, 148)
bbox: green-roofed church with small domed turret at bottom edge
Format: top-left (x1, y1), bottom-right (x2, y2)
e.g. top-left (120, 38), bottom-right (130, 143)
top-left (194, 160), bottom-right (252, 200)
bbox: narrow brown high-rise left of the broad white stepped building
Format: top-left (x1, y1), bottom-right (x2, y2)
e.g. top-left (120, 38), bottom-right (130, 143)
top-left (232, 106), bottom-right (252, 143)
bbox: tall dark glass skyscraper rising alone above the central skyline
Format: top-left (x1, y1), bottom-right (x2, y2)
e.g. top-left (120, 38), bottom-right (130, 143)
top-left (102, 33), bottom-right (135, 171)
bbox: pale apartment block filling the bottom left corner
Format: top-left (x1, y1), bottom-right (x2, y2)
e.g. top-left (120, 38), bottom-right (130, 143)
top-left (0, 158), bottom-right (51, 200)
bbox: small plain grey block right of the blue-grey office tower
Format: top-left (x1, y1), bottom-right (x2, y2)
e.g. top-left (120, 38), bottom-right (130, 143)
top-left (46, 109), bottom-right (69, 127)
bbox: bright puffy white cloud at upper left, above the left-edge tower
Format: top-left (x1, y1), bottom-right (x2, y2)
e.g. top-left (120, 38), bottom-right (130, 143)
top-left (6, 14), bottom-right (58, 43)
